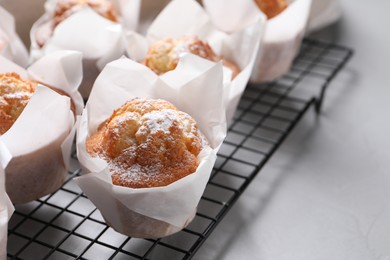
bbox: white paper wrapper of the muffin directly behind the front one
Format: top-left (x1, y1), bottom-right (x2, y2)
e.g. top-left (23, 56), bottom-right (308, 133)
top-left (127, 0), bottom-right (265, 124)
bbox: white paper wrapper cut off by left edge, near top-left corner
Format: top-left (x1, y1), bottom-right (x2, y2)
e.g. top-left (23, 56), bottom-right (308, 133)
top-left (0, 6), bottom-right (28, 67)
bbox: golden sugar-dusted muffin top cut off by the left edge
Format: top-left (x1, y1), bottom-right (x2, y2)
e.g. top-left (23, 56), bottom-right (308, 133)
top-left (0, 72), bottom-right (38, 135)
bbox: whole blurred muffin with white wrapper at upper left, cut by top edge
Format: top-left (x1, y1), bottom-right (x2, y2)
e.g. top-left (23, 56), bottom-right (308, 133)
top-left (30, 0), bottom-right (141, 98)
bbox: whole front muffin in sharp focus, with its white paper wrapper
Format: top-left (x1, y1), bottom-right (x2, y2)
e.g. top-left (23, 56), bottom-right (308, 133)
top-left (75, 55), bottom-right (226, 238)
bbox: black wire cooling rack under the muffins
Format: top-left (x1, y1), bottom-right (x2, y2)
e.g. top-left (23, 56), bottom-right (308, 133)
top-left (8, 39), bottom-right (352, 259)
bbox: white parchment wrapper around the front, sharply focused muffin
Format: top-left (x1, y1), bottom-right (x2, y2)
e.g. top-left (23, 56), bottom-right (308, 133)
top-left (75, 54), bottom-right (226, 237)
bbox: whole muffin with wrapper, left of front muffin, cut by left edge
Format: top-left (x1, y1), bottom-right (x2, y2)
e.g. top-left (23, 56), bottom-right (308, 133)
top-left (0, 72), bottom-right (75, 203)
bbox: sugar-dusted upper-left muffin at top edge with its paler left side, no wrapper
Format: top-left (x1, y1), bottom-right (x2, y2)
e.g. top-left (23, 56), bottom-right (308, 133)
top-left (36, 0), bottom-right (118, 47)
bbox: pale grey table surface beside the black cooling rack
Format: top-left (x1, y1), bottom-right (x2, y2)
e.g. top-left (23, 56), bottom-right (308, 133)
top-left (1, 0), bottom-right (390, 260)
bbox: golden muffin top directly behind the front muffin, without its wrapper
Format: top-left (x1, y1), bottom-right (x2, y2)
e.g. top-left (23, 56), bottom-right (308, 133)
top-left (143, 36), bottom-right (240, 78)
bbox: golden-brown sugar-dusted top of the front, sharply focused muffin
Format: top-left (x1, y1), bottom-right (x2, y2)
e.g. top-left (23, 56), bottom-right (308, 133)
top-left (86, 98), bottom-right (205, 188)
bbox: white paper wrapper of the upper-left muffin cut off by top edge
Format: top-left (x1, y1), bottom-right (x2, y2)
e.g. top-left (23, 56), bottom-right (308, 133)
top-left (30, 0), bottom-right (140, 98)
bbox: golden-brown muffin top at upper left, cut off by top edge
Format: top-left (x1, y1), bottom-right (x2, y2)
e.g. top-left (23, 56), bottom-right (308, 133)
top-left (53, 0), bottom-right (118, 28)
